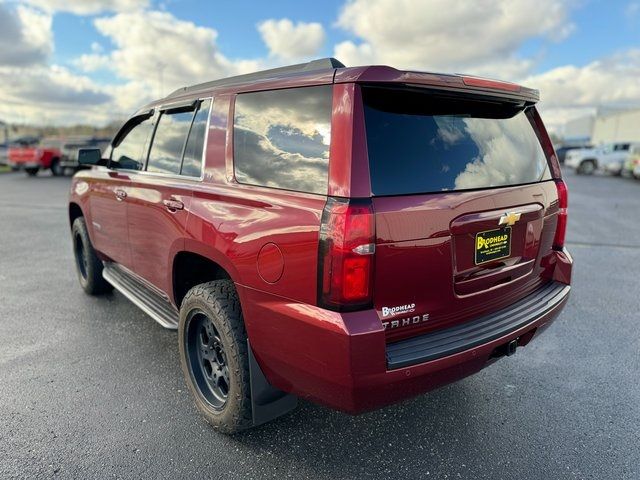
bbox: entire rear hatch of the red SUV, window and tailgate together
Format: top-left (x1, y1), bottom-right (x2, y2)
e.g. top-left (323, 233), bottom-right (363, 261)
top-left (362, 86), bottom-right (559, 341)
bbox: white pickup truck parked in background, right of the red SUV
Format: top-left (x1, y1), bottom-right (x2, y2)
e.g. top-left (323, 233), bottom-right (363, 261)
top-left (565, 142), bottom-right (635, 175)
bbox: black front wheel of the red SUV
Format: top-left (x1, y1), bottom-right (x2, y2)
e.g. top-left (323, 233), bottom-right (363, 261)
top-left (71, 217), bottom-right (113, 295)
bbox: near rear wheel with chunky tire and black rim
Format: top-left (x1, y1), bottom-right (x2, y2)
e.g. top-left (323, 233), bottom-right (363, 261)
top-left (178, 280), bottom-right (253, 433)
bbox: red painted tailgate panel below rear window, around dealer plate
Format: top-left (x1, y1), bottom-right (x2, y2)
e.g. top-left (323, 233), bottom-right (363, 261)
top-left (374, 181), bottom-right (558, 341)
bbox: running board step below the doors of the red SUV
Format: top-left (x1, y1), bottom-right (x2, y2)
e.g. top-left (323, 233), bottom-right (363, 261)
top-left (102, 263), bottom-right (179, 330)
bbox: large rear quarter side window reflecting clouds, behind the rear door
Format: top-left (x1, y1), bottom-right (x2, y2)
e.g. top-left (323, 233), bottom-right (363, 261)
top-left (233, 85), bottom-right (332, 194)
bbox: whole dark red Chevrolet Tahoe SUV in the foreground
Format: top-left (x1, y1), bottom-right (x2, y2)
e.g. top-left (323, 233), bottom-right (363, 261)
top-left (69, 59), bottom-right (572, 432)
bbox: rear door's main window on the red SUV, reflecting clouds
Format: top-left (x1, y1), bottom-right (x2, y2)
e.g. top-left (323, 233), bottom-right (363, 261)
top-left (147, 110), bottom-right (193, 175)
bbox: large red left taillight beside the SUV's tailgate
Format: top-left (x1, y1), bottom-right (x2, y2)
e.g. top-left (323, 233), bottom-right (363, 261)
top-left (318, 198), bottom-right (375, 311)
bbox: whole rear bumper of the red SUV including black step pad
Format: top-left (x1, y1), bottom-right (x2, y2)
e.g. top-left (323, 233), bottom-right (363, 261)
top-left (238, 262), bottom-right (570, 414)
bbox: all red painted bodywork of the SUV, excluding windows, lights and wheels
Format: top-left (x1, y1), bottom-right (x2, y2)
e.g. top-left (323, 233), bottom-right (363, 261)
top-left (70, 62), bottom-right (572, 413)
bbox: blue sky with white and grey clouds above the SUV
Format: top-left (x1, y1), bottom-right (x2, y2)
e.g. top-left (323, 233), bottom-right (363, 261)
top-left (0, 0), bottom-right (640, 129)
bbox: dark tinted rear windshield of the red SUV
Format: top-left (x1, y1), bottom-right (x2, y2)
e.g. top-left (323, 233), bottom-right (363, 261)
top-left (363, 87), bottom-right (551, 195)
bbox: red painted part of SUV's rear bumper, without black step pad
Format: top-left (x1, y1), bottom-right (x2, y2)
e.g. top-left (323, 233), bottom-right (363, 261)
top-left (239, 278), bottom-right (564, 414)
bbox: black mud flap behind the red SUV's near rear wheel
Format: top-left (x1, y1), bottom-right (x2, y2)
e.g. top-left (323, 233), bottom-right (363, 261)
top-left (247, 339), bottom-right (298, 426)
